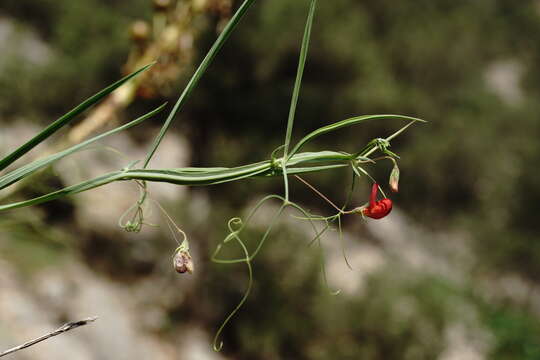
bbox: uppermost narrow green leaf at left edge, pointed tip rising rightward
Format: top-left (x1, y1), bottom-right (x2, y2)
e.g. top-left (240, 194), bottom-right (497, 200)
top-left (0, 63), bottom-right (154, 171)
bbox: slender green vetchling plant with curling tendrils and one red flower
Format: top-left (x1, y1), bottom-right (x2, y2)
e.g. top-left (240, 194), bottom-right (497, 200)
top-left (0, 0), bottom-right (423, 350)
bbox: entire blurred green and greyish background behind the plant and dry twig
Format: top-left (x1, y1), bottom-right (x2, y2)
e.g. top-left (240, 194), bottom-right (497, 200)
top-left (0, 0), bottom-right (540, 360)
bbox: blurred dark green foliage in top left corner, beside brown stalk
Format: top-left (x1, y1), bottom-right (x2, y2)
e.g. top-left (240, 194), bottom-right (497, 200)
top-left (0, 0), bottom-right (151, 118)
